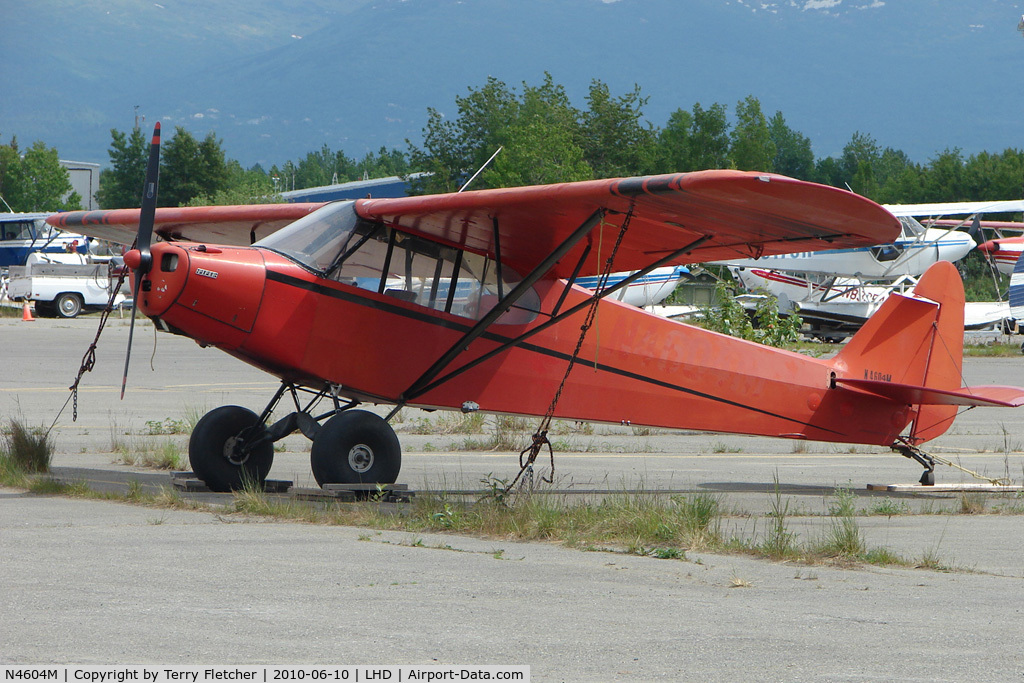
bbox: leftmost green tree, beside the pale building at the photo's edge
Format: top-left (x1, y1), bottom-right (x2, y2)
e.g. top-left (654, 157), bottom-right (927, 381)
top-left (0, 140), bottom-right (82, 212)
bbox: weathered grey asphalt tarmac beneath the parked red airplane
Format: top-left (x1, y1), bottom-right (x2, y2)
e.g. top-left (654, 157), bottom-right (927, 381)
top-left (0, 317), bottom-right (1024, 681)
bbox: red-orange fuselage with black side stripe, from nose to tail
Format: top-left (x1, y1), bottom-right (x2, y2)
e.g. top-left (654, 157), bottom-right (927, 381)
top-left (138, 243), bottom-right (914, 445)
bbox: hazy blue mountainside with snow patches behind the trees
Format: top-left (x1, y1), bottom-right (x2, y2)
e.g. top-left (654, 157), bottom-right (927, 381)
top-left (8, 0), bottom-right (1024, 165)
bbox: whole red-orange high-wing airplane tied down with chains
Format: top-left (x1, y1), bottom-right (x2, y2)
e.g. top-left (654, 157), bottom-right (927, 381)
top-left (48, 128), bottom-right (1024, 490)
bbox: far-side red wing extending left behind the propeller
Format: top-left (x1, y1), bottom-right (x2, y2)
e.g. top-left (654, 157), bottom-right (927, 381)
top-left (46, 204), bottom-right (324, 247)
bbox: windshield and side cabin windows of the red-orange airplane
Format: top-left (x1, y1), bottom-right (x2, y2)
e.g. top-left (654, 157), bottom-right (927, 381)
top-left (255, 202), bottom-right (540, 325)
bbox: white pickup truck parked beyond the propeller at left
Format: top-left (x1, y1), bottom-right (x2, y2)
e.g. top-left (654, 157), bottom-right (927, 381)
top-left (7, 253), bottom-right (125, 317)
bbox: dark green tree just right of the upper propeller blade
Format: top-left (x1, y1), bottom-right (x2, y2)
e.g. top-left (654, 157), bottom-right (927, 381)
top-left (159, 126), bottom-right (228, 206)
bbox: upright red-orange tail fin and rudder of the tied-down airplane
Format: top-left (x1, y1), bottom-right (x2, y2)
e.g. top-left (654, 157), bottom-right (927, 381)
top-left (834, 261), bottom-right (964, 443)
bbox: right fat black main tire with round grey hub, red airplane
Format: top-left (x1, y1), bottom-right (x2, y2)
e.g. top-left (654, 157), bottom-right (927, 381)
top-left (309, 411), bottom-right (401, 486)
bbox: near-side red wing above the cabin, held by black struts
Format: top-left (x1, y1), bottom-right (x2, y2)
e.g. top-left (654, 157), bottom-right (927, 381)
top-left (356, 171), bottom-right (900, 278)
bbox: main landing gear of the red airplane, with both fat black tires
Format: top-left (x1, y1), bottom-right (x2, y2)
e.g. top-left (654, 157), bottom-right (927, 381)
top-left (188, 382), bottom-right (401, 492)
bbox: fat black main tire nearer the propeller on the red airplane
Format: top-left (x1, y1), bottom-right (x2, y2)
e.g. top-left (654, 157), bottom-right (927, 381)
top-left (188, 405), bottom-right (273, 492)
